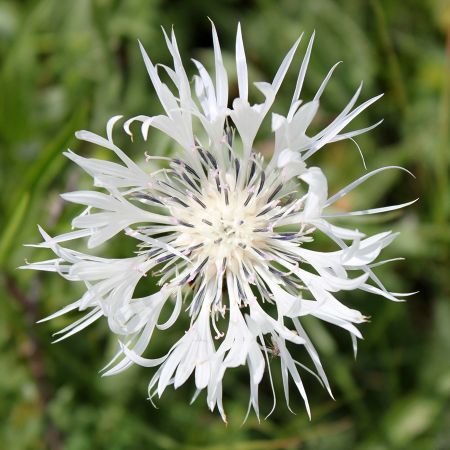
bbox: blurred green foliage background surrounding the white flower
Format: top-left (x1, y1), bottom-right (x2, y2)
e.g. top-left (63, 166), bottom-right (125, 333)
top-left (0, 0), bottom-right (450, 450)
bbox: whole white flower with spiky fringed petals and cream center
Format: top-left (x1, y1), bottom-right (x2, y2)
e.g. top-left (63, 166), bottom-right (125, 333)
top-left (21, 21), bottom-right (411, 420)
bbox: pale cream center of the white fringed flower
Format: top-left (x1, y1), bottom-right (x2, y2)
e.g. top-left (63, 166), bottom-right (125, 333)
top-left (173, 169), bottom-right (270, 275)
